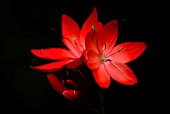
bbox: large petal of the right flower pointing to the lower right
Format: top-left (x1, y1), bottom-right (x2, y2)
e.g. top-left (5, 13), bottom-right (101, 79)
top-left (104, 61), bottom-right (137, 85)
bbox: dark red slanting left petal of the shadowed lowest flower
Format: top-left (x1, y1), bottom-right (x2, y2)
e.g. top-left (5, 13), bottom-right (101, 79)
top-left (47, 73), bottom-right (66, 94)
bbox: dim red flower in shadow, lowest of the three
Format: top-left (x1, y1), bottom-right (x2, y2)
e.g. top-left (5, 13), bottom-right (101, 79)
top-left (47, 70), bottom-right (87, 103)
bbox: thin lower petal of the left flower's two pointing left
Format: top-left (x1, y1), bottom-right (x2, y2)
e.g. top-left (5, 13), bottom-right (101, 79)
top-left (30, 60), bottom-right (72, 72)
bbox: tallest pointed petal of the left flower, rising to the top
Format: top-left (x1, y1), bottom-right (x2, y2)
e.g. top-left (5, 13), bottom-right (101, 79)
top-left (80, 8), bottom-right (98, 46)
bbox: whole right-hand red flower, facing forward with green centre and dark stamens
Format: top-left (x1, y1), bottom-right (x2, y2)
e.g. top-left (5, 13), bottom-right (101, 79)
top-left (85, 20), bottom-right (146, 88)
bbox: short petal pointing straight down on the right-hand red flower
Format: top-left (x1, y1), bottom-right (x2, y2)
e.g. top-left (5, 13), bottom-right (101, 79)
top-left (93, 64), bottom-right (110, 88)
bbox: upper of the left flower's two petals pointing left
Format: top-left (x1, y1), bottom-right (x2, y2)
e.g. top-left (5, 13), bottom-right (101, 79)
top-left (31, 48), bottom-right (75, 60)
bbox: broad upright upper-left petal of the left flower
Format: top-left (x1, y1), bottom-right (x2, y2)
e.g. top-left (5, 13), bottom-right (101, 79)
top-left (62, 15), bottom-right (80, 38)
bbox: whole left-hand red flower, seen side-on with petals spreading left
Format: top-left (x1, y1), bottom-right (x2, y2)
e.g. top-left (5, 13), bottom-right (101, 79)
top-left (31, 8), bottom-right (102, 72)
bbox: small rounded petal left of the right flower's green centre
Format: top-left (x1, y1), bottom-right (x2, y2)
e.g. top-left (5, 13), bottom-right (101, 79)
top-left (86, 50), bottom-right (100, 70)
